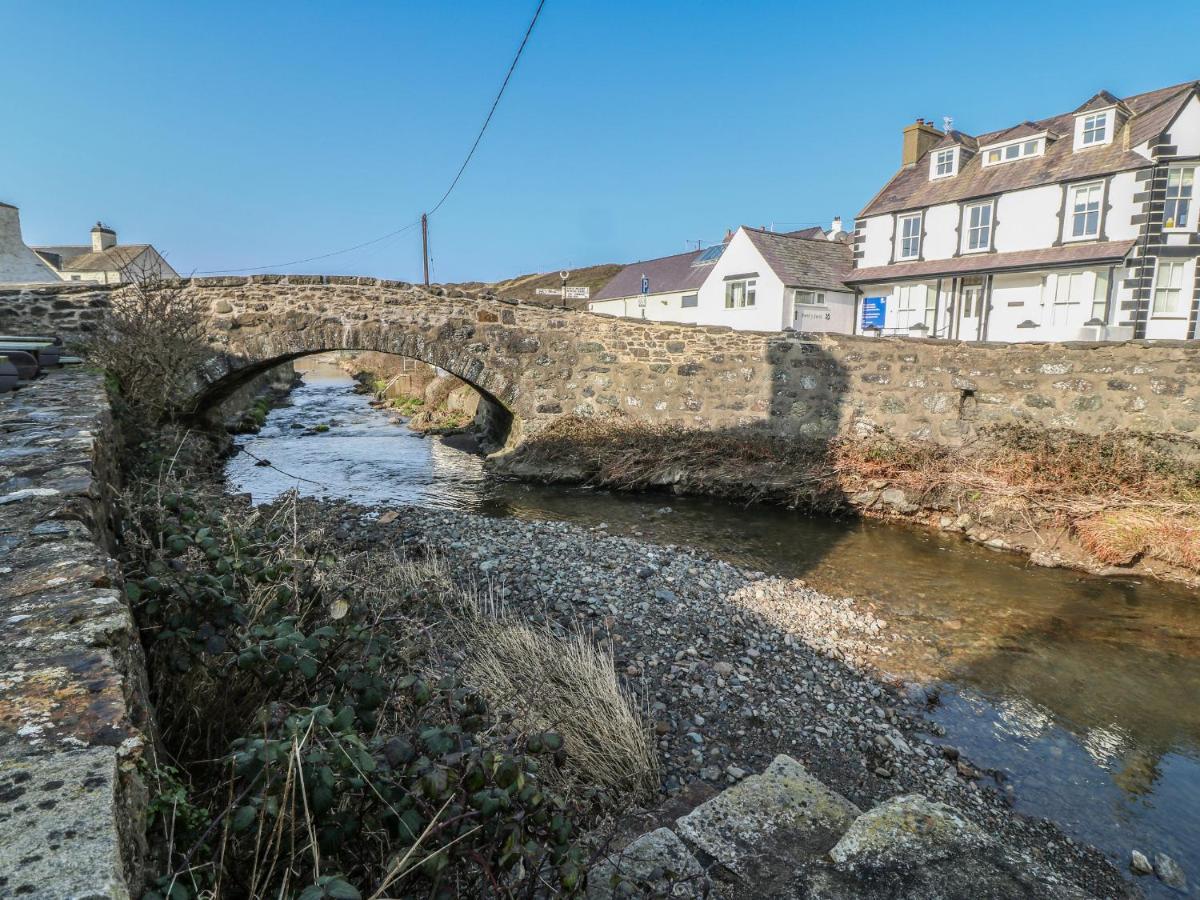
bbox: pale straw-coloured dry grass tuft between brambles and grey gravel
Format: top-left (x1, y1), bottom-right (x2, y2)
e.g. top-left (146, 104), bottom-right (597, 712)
top-left (463, 617), bottom-right (659, 798)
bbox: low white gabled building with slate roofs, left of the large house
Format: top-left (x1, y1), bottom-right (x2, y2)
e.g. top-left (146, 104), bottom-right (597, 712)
top-left (588, 220), bottom-right (854, 334)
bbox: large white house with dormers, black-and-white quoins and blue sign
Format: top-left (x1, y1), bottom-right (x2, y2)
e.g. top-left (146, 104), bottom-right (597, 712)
top-left (846, 82), bottom-right (1200, 341)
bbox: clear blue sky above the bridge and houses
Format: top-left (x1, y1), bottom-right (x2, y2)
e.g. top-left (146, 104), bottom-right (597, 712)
top-left (0, 0), bottom-right (1200, 281)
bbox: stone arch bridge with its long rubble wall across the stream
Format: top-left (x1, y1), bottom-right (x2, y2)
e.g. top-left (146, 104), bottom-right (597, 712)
top-left (0, 275), bottom-right (1200, 445)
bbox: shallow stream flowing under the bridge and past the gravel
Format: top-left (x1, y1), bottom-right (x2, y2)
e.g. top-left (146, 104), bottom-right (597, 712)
top-left (228, 367), bottom-right (1200, 893)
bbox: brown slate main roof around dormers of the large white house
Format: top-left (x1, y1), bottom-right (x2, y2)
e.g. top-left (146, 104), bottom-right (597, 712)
top-left (858, 82), bottom-right (1200, 217)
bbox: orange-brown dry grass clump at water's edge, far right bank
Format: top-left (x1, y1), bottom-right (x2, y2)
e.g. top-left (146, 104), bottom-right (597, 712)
top-left (1075, 508), bottom-right (1200, 569)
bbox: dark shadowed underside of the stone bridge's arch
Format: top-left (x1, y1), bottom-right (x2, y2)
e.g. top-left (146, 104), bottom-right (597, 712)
top-left (191, 347), bottom-right (520, 452)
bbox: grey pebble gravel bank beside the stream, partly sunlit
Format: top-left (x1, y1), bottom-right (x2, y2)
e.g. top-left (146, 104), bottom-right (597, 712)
top-left (302, 504), bottom-right (1135, 896)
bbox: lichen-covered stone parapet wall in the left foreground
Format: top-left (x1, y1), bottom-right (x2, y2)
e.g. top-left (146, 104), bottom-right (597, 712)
top-left (0, 371), bottom-right (150, 900)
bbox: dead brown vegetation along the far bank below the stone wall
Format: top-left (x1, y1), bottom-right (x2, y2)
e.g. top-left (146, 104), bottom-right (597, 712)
top-left (506, 416), bottom-right (1200, 570)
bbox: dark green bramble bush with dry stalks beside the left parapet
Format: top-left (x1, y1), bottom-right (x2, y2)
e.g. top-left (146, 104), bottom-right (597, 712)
top-left (122, 479), bottom-right (590, 900)
